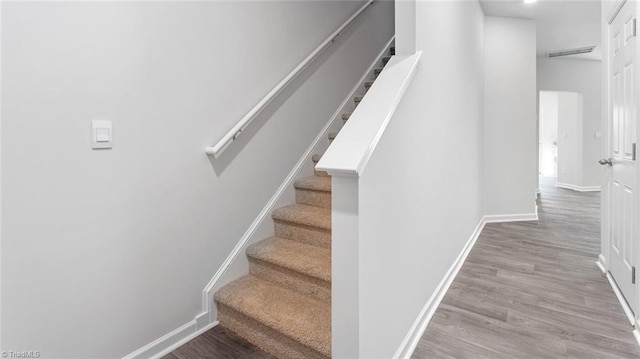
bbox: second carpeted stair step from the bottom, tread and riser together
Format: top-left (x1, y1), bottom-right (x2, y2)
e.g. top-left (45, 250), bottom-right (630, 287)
top-left (247, 237), bottom-right (331, 303)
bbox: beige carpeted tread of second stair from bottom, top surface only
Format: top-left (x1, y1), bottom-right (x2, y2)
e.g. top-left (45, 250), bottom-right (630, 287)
top-left (247, 237), bottom-right (331, 282)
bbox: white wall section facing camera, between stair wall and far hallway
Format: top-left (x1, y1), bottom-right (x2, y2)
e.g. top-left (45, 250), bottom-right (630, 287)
top-left (483, 16), bottom-right (538, 215)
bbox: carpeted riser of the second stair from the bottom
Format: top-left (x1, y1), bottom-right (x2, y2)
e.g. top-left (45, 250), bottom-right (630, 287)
top-left (249, 257), bottom-right (331, 303)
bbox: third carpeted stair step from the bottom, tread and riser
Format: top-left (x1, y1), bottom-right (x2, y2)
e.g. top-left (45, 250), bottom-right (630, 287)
top-left (271, 204), bottom-right (331, 248)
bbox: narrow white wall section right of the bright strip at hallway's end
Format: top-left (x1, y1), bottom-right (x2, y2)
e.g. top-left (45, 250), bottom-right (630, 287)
top-left (557, 92), bottom-right (583, 186)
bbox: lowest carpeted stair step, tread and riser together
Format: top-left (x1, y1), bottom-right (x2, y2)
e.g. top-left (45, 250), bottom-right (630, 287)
top-left (215, 276), bottom-right (331, 359)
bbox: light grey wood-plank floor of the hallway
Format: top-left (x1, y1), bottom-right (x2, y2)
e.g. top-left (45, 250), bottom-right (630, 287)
top-left (413, 179), bottom-right (640, 359)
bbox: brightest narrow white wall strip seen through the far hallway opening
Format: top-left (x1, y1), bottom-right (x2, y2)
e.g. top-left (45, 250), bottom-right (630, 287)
top-left (538, 91), bottom-right (558, 177)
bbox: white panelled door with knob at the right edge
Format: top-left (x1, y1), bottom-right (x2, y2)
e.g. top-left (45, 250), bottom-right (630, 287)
top-left (601, 1), bottom-right (638, 311)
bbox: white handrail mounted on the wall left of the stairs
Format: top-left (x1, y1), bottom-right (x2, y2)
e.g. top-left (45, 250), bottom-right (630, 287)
top-left (205, 0), bottom-right (374, 158)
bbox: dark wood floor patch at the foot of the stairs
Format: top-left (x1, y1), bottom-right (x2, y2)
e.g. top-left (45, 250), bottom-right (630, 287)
top-left (162, 325), bottom-right (274, 359)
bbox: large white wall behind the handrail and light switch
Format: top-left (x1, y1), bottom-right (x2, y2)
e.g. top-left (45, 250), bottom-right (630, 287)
top-left (1, 1), bottom-right (393, 358)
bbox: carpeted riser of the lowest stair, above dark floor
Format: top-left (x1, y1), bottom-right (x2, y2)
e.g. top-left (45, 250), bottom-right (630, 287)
top-left (216, 303), bottom-right (329, 359)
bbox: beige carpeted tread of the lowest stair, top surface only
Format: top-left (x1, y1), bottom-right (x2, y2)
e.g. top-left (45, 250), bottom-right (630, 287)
top-left (215, 276), bottom-right (331, 357)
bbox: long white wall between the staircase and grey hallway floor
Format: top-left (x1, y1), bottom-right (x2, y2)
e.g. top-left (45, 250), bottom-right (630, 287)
top-left (356, 1), bottom-right (484, 358)
